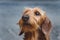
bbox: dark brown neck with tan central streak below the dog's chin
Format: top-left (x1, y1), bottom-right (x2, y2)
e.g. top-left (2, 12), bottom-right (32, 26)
top-left (24, 30), bottom-right (46, 40)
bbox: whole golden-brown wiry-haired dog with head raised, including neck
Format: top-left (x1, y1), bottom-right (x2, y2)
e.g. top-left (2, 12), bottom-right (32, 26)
top-left (17, 7), bottom-right (52, 40)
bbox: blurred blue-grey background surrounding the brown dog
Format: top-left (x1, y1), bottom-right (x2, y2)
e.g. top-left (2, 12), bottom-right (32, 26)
top-left (0, 0), bottom-right (60, 40)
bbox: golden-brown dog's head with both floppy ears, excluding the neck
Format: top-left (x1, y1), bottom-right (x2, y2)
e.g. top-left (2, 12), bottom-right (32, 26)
top-left (18, 7), bottom-right (51, 35)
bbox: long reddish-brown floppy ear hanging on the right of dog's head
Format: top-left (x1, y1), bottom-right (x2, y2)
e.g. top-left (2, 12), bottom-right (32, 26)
top-left (41, 17), bottom-right (52, 34)
